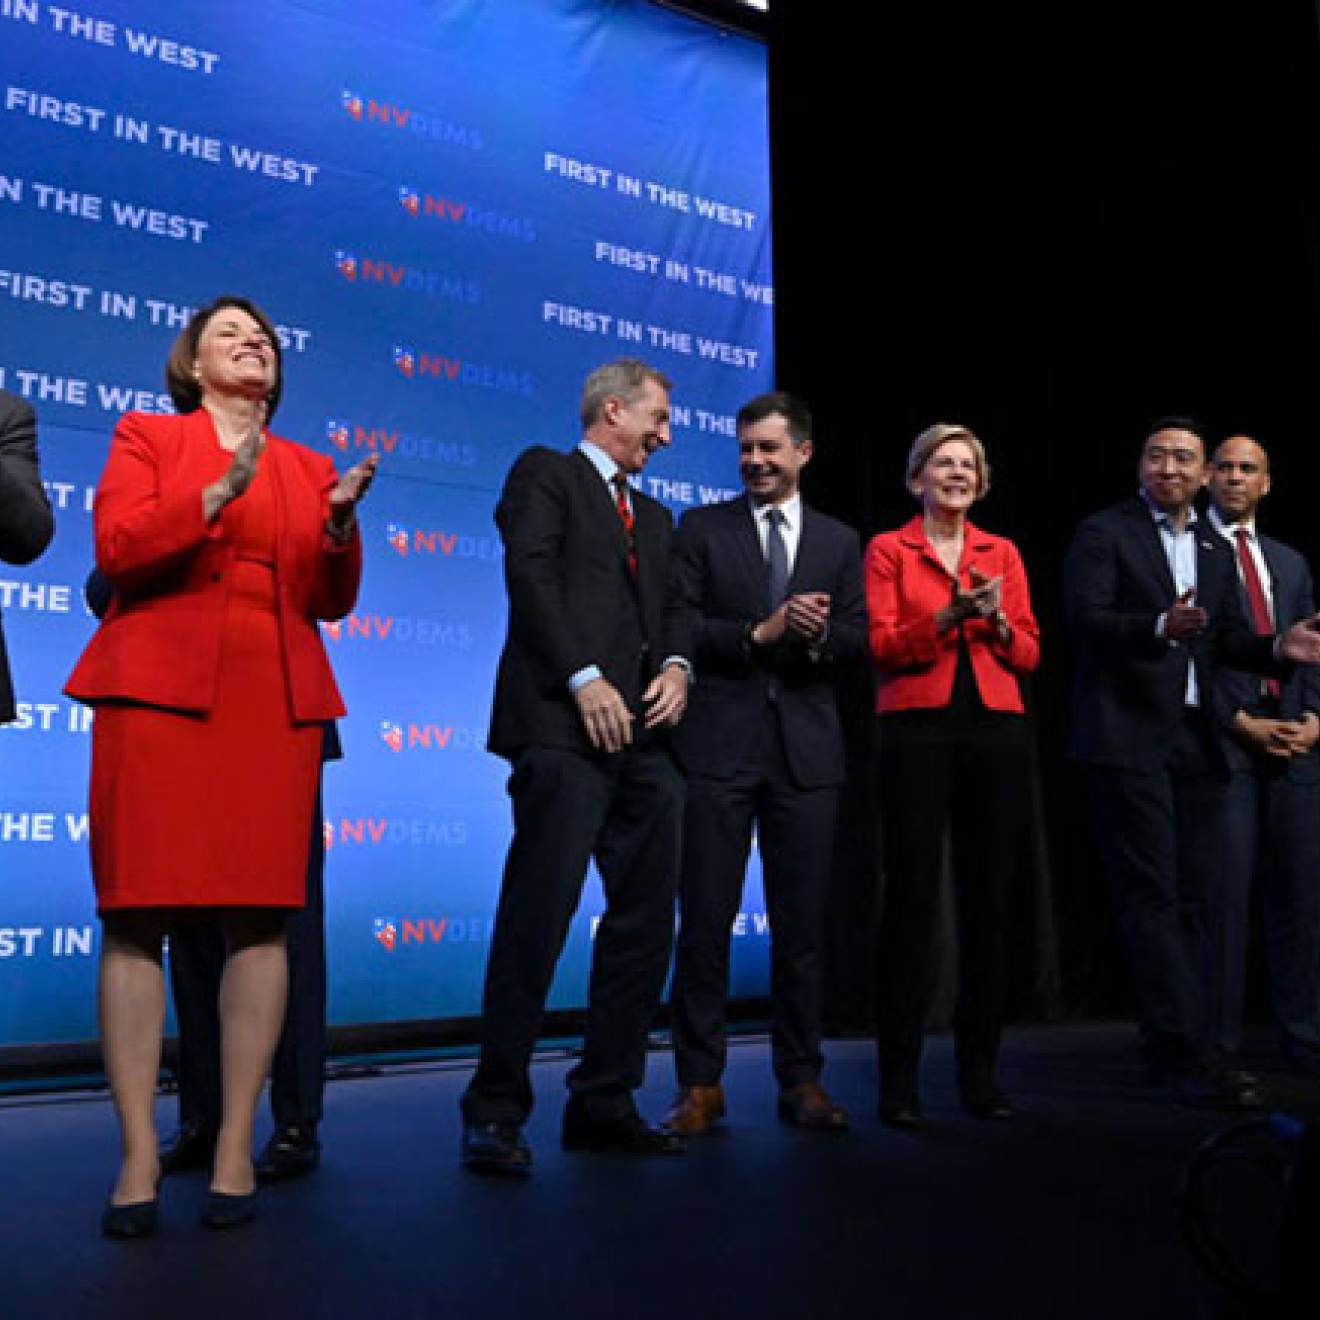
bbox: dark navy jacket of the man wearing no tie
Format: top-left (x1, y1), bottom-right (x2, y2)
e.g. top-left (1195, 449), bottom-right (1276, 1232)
top-left (1064, 496), bottom-right (1287, 771)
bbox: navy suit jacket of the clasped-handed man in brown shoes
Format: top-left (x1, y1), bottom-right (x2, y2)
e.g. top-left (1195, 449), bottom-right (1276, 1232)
top-left (669, 498), bottom-right (867, 788)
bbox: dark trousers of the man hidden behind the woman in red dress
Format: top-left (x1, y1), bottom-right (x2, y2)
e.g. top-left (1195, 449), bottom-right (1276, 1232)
top-left (169, 791), bottom-right (326, 1131)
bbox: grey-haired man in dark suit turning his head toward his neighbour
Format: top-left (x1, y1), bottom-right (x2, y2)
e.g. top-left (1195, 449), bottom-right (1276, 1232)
top-left (462, 358), bottom-right (690, 1175)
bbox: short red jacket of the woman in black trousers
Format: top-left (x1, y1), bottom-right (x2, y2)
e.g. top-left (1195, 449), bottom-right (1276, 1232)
top-left (865, 515), bottom-right (1040, 713)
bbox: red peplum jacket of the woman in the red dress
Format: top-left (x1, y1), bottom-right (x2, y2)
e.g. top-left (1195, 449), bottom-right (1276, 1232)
top-left (65, 408), bottom-right (362, 722)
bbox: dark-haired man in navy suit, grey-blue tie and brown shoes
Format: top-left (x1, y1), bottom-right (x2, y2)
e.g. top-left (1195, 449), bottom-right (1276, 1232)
top-left (665, 393), bottom-right (867, 1135)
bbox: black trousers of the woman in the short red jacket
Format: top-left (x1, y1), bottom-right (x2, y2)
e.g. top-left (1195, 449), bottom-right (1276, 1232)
top-left (878, 711), bottom-right (1028, 1102)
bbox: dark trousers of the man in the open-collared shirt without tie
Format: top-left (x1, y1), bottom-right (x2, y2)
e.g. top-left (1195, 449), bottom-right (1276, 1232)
top-left (1088, 709), bottom-right (1229, 1069)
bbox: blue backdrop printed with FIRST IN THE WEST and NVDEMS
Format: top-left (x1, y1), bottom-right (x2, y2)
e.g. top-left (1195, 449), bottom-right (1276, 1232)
top-left (0, 0), bottom-right (774, 1047)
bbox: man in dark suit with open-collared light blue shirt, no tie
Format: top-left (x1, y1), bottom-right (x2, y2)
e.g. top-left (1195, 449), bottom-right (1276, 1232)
top-left (1065, 418), bottom-right (1320, 1109)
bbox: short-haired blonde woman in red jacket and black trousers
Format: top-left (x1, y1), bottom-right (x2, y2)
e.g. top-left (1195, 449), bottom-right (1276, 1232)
top-left (865, 425), bottom-right (1040, 1129)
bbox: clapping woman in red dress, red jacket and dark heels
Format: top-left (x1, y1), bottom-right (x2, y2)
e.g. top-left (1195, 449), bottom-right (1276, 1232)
top-left (66, 297), bottom-right (375, 1237)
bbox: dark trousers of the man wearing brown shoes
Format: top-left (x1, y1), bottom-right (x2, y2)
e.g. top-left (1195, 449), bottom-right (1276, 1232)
top-left (669, 706), bottom-right (838, 1090)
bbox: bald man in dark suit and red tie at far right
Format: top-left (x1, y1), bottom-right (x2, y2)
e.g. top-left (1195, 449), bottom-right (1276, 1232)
top-left (1205, 436), bottom-right (1320, 1077)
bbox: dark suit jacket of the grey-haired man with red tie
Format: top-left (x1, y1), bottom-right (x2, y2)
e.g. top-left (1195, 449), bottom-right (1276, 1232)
top-left (487, 446), bottom-right (690, 758)
